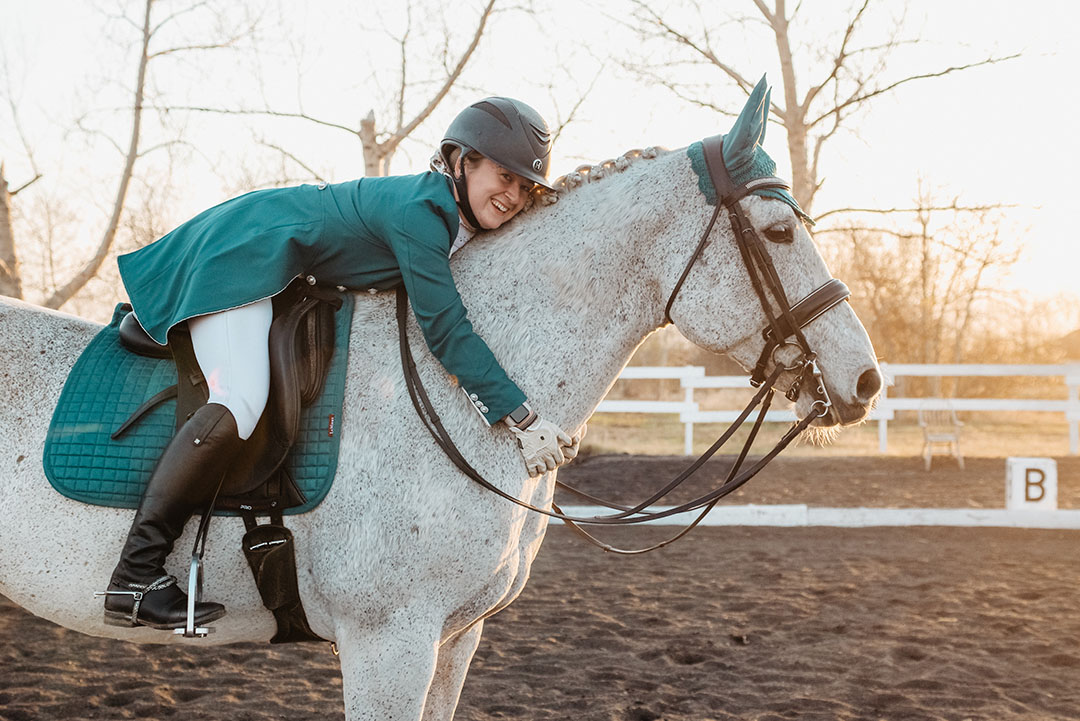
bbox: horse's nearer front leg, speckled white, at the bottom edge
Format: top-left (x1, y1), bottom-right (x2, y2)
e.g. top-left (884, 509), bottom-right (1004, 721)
top-left (337, 613), bottom-right (438, 721)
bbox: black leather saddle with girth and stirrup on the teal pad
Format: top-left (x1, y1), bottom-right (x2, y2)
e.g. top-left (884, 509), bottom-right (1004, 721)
top-left (112, 280), bottom-right (342, 643)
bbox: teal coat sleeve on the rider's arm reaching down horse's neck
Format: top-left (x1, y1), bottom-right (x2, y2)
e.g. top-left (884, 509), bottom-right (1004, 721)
top-left (387, 201), bottom-right (525, 424)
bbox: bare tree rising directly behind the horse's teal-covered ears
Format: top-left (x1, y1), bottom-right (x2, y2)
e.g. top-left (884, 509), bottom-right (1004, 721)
top-left (624, 0), bottom-right (1016, 213)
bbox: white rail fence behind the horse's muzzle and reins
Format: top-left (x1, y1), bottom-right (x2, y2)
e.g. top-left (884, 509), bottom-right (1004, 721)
top-left (596, 363), bottom-right (1080, 455)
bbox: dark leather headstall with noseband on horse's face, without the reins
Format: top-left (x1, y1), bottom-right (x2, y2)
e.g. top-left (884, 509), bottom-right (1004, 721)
top-left (664, 135), bottom-right (851, 416)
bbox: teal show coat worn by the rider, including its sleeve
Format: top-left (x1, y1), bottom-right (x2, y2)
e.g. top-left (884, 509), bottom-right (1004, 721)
top-left (118, 173), bottom-right (525, 423)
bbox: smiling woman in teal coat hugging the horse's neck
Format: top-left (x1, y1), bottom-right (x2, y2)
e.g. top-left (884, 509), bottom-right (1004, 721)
top-left (105, 97), bottom-right (580, 629)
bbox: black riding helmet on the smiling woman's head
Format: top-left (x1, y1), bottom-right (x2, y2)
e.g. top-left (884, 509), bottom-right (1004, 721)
top-left (438, 97), bottom-right (551, 228)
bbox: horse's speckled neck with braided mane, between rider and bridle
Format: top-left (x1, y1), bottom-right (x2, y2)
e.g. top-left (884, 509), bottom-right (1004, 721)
top-left (455, 166), bottom-right (661, 428)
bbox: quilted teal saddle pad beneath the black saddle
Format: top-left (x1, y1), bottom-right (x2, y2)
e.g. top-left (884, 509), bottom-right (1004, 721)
top-left (43, 294), bottom-right (353, 515)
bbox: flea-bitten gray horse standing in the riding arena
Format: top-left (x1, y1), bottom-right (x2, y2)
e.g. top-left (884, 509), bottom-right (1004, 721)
top-left (0, 85), bottom-right (880, 721)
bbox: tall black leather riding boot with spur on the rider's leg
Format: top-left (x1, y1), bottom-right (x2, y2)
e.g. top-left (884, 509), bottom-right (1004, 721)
top-left (105, 404), bottom-right (243, 628)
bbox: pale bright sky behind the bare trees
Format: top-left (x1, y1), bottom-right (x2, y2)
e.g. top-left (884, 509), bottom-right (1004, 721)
top-left (0, 0), bottom-right (1080, 306)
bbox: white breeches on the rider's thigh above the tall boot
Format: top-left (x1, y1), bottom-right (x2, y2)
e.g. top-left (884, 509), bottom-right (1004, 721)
top-left (188, 298), bottom-right (273, 440)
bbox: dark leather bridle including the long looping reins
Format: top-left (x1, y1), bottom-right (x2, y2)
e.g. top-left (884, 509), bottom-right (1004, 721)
top-left (397, 136), bottom-right (851, 554)
